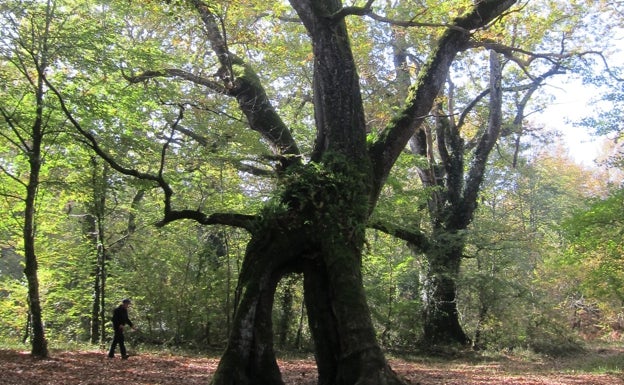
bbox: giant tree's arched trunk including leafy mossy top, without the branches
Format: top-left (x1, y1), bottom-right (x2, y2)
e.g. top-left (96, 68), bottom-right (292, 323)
top-left (213, 157), bottom-right (401, 385)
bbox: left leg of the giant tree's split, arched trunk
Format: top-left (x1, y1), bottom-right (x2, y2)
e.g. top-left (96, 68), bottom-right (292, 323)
top-left (212, 219), bottom-right (302, 385)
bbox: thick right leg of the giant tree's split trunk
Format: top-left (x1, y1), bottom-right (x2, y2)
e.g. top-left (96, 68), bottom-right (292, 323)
top-left (304, 246), bottom-right (402, 385)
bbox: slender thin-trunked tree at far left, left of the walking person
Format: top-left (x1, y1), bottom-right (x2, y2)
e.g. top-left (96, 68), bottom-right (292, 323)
top-left (0, 2), bottom-right (68, 357)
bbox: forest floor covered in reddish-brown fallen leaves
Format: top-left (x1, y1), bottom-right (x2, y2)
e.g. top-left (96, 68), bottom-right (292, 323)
top-left (0, 347), bottom-right (624, 385)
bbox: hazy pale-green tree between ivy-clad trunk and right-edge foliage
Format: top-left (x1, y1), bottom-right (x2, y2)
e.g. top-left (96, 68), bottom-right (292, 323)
top-left (459, 146), bottom-right (605, 348)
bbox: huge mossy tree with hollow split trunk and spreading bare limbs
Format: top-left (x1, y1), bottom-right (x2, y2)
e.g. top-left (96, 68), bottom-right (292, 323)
top-left (48, 0), bottom-right (515, 384)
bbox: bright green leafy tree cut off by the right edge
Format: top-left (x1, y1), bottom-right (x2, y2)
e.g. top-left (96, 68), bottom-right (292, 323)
top-left (550, 189), bottom-right (624, 338)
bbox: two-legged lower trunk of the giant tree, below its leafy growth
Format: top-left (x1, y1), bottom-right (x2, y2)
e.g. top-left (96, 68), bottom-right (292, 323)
top-left (212, 188), bottom-right (402, 385)
